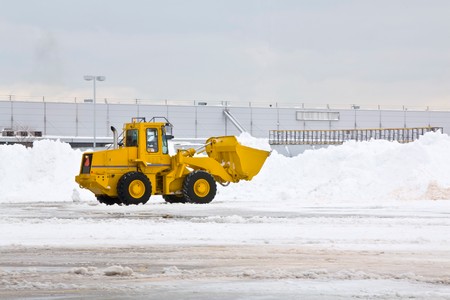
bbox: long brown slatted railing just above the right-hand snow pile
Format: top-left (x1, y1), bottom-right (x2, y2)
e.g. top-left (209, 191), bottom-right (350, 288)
top-left (269, 127), bottom-right (442, 145)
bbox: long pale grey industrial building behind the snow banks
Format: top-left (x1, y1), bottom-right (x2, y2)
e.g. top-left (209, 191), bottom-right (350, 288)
top-left (0, 99), bottom-right (450, 154)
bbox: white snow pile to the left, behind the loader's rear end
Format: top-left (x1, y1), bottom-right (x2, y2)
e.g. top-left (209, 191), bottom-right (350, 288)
top-left (0, 140), bottom-right (92, 202)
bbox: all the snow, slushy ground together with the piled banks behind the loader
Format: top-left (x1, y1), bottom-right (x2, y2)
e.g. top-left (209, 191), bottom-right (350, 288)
top-left (0, 133), bottom-right (450, 299)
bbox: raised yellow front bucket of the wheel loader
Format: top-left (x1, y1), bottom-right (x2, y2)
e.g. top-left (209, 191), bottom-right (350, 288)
top-left (206, 136), bottom-right (270, 182)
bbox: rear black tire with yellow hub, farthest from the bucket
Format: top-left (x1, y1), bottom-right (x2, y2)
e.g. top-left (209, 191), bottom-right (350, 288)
top-left (117, 172), bottom-right (152, 205)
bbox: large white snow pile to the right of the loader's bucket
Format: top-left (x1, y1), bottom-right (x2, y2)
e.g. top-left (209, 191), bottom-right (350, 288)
top-left (221, 133), bottom-right (450, 205)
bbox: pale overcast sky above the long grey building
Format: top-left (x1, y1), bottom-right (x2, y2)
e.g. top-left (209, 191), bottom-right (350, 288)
top-left (0, 0), bottom-right (450, 106)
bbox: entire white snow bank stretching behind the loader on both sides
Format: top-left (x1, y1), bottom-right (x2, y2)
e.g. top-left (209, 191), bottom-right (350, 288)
top-left (0, 133), bottom-right (450, 205)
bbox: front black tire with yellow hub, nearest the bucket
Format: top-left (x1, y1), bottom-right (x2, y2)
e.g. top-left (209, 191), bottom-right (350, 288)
top-left (183, 171), bottom-right (217, 204)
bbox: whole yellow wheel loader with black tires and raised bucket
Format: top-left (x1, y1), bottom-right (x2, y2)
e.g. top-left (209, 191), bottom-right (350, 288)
top-left (75, 117), bottom-right (270, 205)
